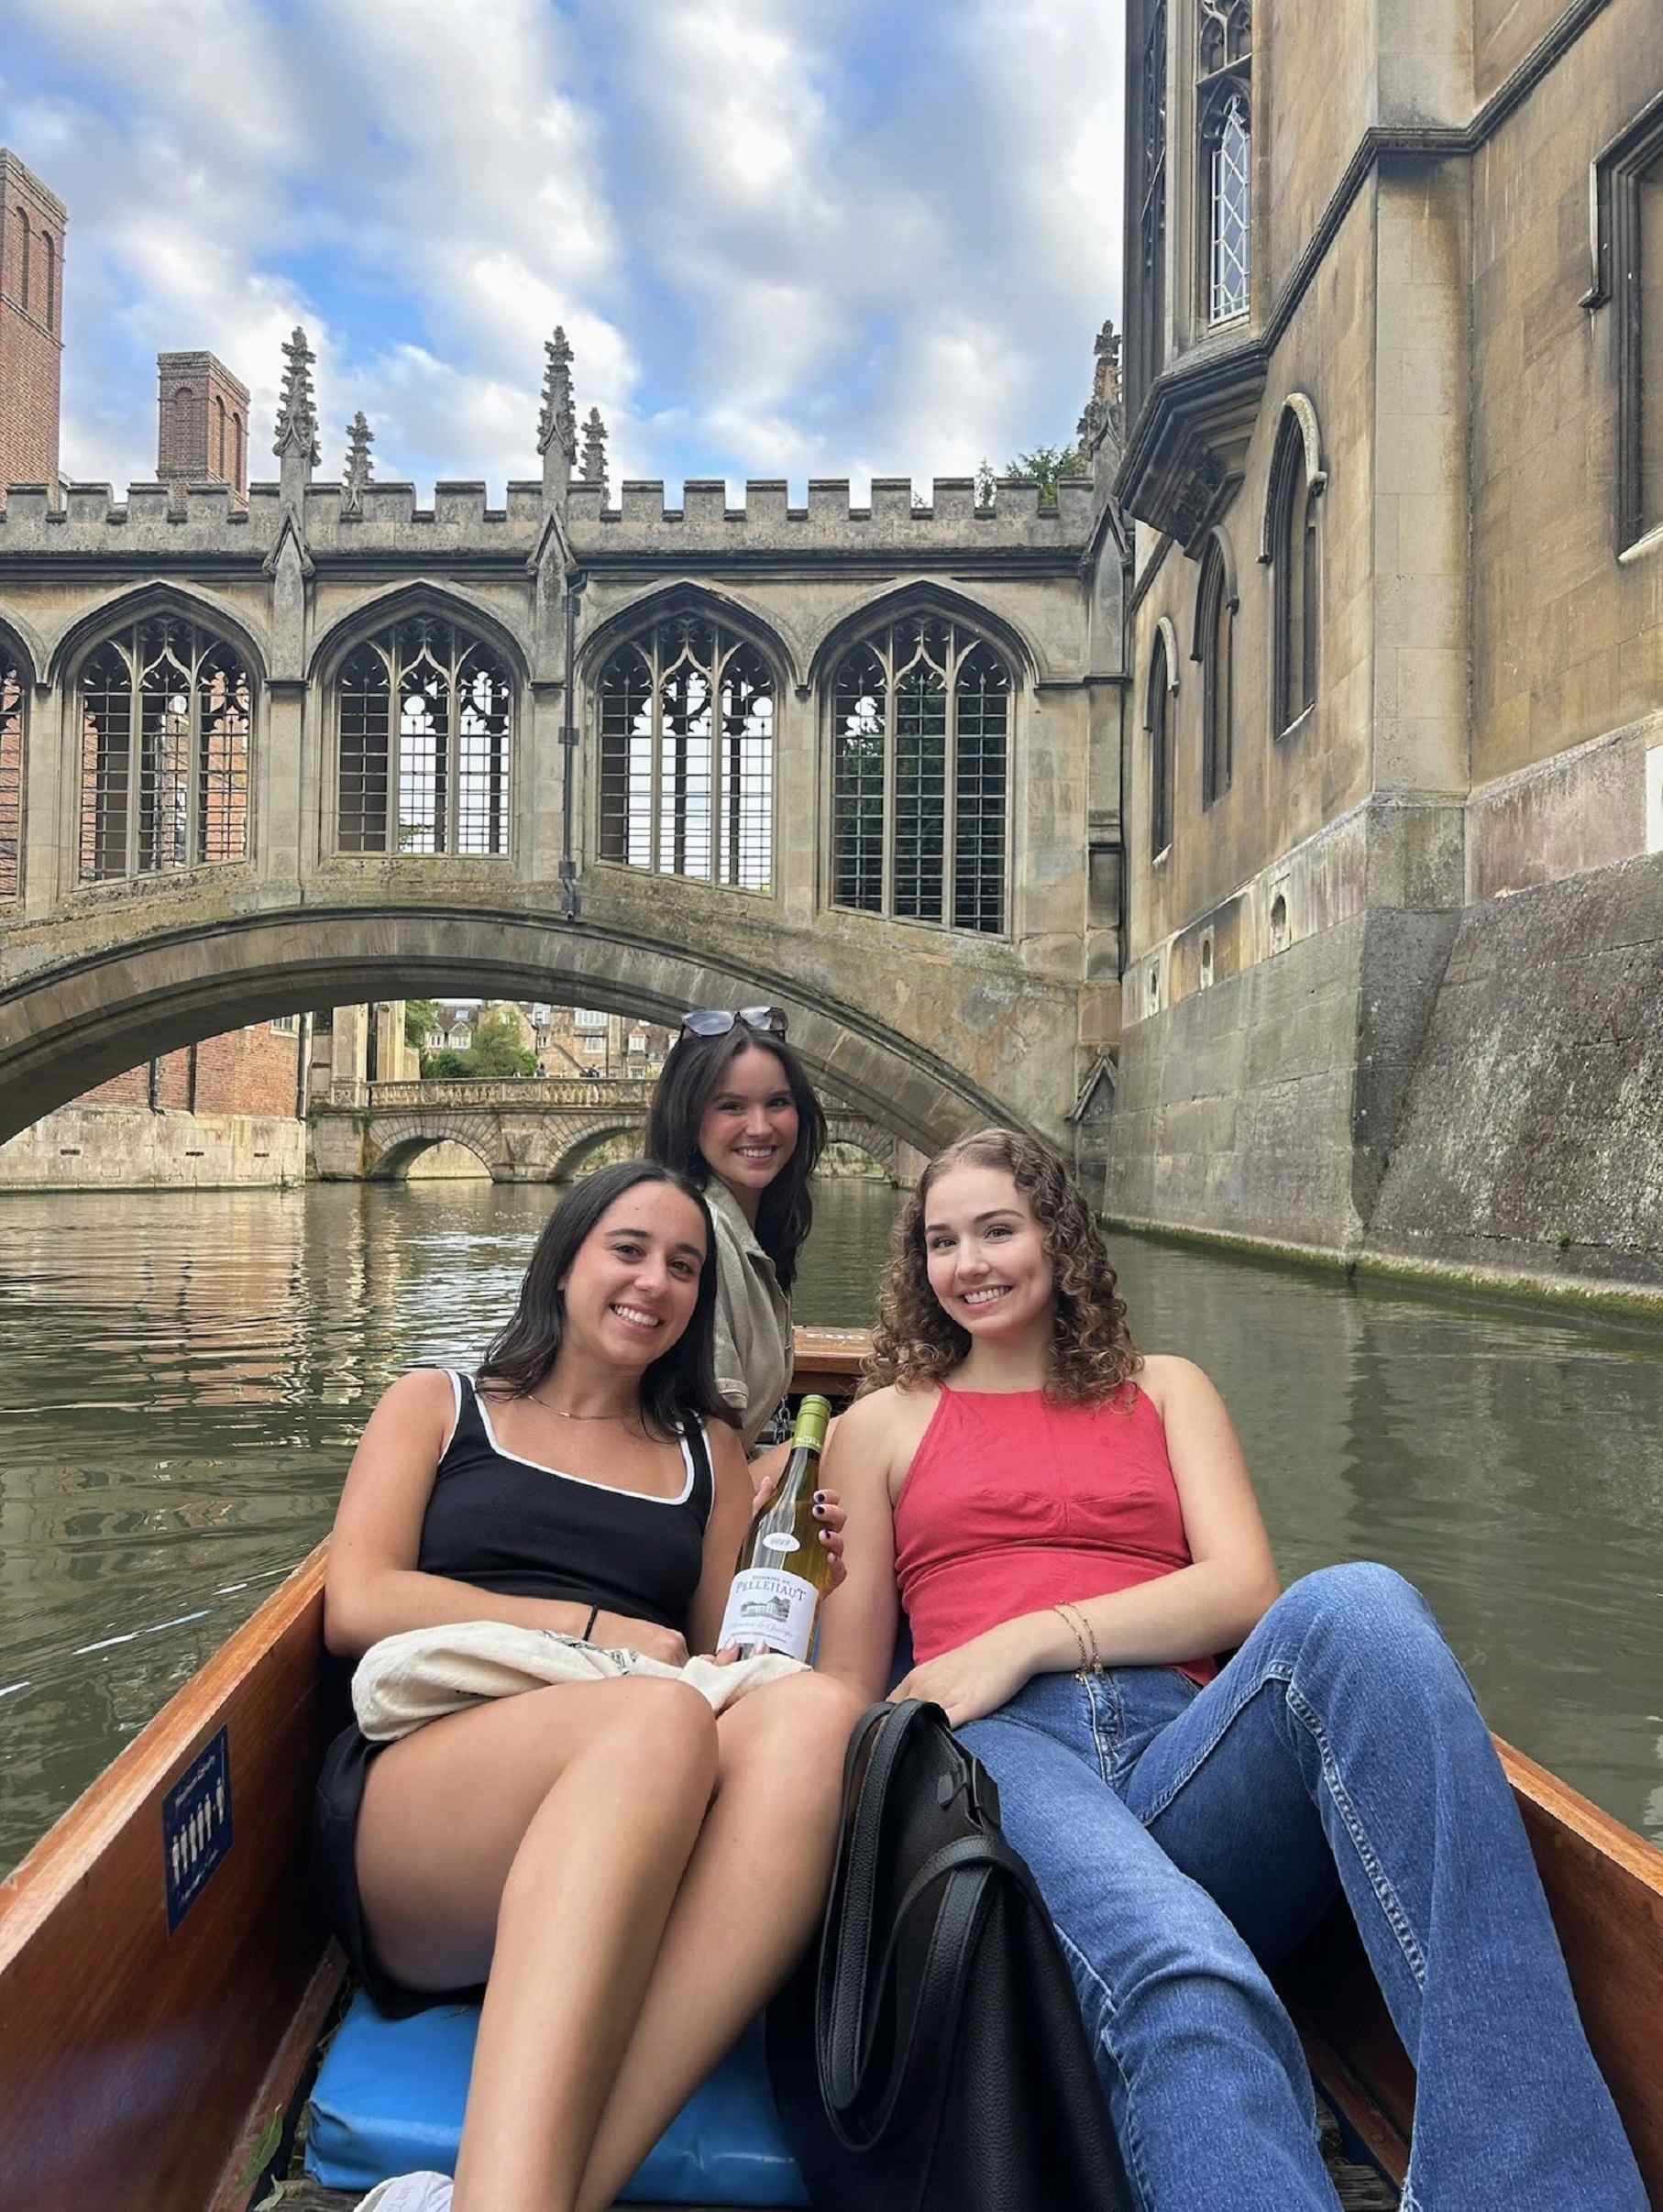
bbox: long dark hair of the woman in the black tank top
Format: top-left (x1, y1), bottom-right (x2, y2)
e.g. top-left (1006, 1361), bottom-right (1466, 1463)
top-left (479, 1159), bottom-right (734, 1436)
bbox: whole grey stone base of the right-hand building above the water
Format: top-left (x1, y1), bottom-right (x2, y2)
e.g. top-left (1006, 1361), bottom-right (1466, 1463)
top-left (1101, 852), bottom-right (1663, 1301)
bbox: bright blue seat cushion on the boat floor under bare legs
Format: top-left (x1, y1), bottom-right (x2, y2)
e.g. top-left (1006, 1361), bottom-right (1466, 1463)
top-left (305, 1991), bottom-right (809, 2206)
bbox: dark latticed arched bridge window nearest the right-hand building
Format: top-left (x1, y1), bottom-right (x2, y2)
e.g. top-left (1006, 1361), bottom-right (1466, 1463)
top-left (832, 615), bottom-right (1013, 936)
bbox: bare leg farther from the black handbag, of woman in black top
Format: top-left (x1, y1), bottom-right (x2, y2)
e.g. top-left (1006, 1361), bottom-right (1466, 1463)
top-left (358, 1678), bottom-right (721, 2212)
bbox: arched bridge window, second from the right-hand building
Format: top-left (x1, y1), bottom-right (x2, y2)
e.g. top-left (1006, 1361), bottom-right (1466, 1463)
top-left (597, 612), bottom-right (778, 891)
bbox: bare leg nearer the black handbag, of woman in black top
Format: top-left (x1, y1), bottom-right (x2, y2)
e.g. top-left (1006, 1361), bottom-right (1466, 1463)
top-left (578, 1675), bottom-right (865, 2212)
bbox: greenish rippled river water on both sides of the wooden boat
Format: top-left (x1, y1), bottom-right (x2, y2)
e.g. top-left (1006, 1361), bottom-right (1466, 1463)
top-left (0, 1182), bottom-right (1663, 1869)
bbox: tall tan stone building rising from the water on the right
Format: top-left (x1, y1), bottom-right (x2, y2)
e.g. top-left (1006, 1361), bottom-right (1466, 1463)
top-left (1106, 0), bottom-right (1663, 1283)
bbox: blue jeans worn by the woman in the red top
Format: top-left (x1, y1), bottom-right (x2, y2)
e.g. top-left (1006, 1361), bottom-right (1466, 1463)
top-left (960, 1566), bottom-right (1647, 2212)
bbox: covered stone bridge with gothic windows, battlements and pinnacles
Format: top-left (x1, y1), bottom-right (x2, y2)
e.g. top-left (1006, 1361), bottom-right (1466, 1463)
top-left (0, 242), bottom-right (1123, 1146)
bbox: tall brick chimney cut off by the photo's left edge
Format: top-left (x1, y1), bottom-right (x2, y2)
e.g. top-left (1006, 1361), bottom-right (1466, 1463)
top-left (0, 146), bottom-right (69, 507)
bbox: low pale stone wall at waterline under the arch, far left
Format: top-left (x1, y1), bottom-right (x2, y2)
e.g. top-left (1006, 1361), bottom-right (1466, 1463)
top-left (0, 1106), bottom-right (305, 1196)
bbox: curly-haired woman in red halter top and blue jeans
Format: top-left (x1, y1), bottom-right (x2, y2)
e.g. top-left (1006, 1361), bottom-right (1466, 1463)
top-left (819, 1130), bottom-right (1646, 2212)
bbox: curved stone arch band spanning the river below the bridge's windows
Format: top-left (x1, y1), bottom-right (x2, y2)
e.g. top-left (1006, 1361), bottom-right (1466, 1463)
top-left (0, 887), bottom-right (1021, 1152)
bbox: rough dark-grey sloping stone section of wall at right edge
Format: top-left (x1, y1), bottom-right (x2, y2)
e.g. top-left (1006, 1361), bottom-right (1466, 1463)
top-left (1369, 853), bottom-right (1663, 1287)
